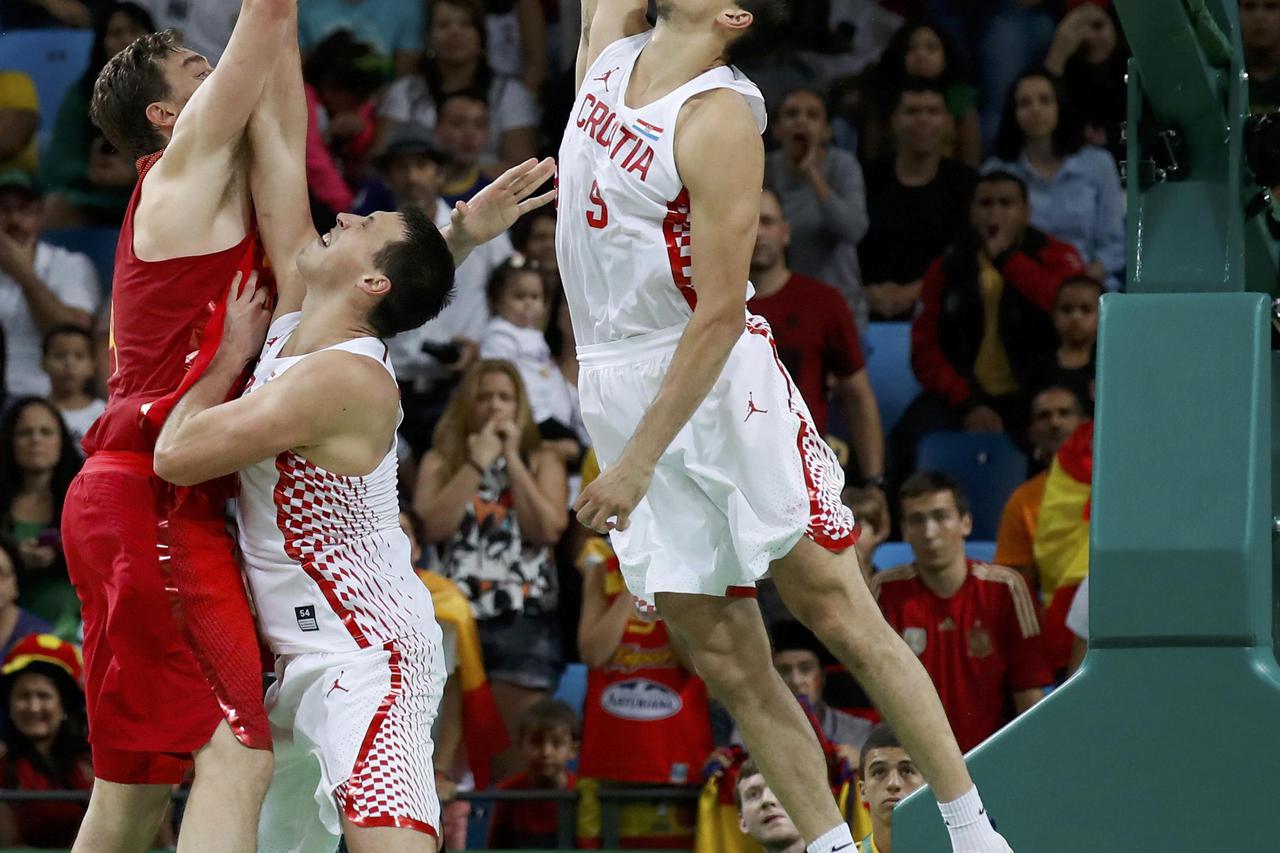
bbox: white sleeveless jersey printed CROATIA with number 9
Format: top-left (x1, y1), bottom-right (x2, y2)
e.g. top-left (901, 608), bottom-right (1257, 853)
top-left (556, 32), bottom-right (765, 346)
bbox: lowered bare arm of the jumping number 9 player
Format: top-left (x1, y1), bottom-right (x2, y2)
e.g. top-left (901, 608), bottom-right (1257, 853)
top-left (573, 90), bottom-right (764, 533)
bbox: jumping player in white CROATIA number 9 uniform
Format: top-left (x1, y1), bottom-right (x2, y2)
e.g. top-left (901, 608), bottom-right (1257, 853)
top-left (557, 0), bottom-right (1009, 853)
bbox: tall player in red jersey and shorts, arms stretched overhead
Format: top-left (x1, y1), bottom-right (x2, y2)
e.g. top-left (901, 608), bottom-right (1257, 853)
top-left (63, 0), bottom-right (296, 853)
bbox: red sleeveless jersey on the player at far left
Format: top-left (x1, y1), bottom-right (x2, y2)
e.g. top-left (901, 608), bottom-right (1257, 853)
top-left (84, 151), bottom-right (262, 453)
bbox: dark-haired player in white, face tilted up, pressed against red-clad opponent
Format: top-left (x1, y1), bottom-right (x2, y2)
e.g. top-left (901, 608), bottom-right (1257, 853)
top-left (155, 38), bottom-right (554, 853)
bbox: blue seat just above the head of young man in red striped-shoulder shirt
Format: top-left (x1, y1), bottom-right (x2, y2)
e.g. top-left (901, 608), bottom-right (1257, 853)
top-left (915, 432), bottom-right (1027, 539)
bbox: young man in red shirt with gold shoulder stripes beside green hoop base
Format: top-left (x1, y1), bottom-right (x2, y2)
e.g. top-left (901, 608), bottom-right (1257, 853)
top-left (872, 471), bottom-right (1053, 752)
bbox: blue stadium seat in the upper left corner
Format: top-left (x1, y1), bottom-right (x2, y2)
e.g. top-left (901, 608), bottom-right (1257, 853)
top-left (0, 29), bottom-right (93, 149)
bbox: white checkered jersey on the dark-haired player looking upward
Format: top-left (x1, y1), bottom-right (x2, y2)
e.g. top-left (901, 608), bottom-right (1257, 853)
top-left (236, 313), bottom-right (439, 654)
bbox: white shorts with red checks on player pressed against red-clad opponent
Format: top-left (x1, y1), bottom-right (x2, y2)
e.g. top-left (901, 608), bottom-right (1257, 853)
top-left (257, 634), bottom-right (444, 853)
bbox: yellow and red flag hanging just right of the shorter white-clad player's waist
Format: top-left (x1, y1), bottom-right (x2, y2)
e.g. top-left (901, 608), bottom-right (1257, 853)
top-left (417, 571), bottom-right (511, 788)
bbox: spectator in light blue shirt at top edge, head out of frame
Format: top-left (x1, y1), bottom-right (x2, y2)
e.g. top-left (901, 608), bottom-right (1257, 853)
top-left (298, 0), bottom-right (426, 74)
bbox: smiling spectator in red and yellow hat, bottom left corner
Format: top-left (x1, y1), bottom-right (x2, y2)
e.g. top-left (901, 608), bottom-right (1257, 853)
top-left (0, 634), bottom-right (93, 848)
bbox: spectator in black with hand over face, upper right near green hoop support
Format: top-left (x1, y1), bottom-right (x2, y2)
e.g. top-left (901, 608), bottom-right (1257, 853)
top-left (1044, 0), bottom-right (1126, 161)
